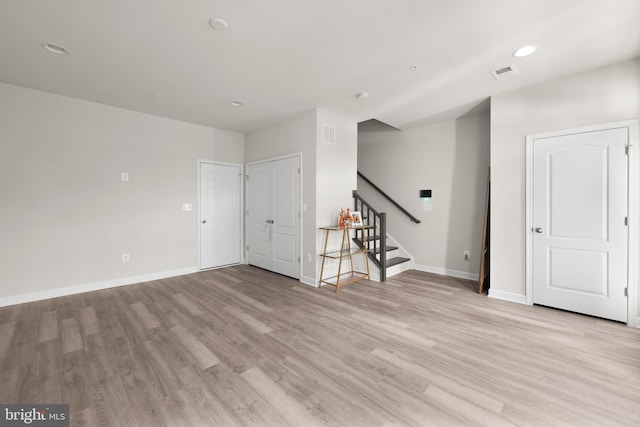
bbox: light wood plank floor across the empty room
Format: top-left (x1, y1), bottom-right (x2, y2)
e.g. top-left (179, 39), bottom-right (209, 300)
top-left (0, 266), bottom-right (640, 426)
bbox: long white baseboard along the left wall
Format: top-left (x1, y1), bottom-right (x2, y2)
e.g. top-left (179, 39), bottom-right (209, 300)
top-left (0, 267), bottom-right (199, 307)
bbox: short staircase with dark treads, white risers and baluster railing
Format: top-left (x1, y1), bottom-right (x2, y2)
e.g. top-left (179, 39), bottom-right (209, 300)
top-left (353, 190), bottom-right (413, 282)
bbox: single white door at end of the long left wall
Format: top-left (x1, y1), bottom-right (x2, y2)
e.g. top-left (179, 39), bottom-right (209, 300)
top-left (199, 162), bottom-right (242, 269)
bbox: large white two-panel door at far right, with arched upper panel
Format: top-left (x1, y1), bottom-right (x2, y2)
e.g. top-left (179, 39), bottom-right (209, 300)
top-left (530, 128), bottom-right (629, 322)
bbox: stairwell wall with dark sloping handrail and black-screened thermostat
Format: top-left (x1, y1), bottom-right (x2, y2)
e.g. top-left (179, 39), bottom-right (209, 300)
top-left (358, 113), bottom-right (489, 278)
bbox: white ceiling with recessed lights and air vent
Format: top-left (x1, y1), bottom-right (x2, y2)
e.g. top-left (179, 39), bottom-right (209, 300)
top-left (0, 0), bottom-right (640, 132)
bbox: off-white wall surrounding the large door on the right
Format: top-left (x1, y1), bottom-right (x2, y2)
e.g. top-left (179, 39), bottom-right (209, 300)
top-left (491, 59), bottom-right (640, 320)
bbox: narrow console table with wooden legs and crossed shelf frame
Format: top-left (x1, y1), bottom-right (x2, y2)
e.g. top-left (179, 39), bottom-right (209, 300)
top-left (320, 225), bottom-right (371, 293)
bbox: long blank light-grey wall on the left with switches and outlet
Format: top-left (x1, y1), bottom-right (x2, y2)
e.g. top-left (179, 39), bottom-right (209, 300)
top-left (0, 84), bottom-right (244, 302)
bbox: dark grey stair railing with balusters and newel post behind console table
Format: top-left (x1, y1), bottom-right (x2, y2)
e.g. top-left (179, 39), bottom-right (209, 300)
top-left (353, 190), bottom-right (387, 282)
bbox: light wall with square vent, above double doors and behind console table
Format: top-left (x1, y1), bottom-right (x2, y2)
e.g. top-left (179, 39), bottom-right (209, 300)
top-left (245, 109), bottom-right (357, 284)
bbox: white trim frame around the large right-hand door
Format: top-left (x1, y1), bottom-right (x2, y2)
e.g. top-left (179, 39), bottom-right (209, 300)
top-left (525, 120), bottom-right (640, 328)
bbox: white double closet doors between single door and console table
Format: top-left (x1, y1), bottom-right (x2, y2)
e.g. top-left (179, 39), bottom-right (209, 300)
top-left (247, 157), bottom-right (301, 278)
